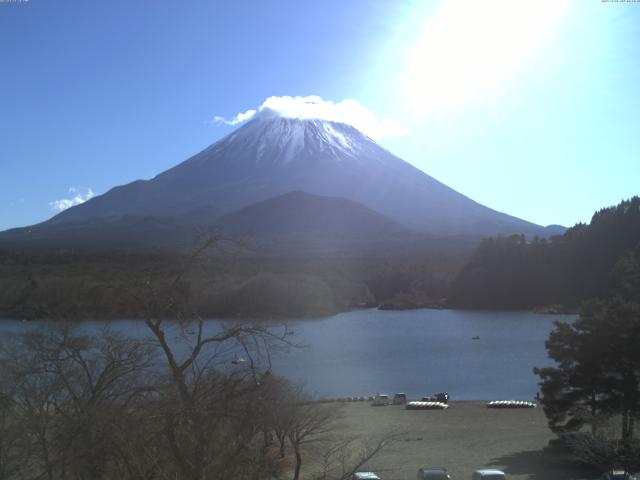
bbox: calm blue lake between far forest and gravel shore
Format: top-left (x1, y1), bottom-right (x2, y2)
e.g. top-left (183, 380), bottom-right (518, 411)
top-left (0, 309), bottom-right (576, 400)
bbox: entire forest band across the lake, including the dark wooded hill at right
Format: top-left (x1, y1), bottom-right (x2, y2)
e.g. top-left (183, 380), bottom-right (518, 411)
top-left (7, 197), bottom-right (640, 319)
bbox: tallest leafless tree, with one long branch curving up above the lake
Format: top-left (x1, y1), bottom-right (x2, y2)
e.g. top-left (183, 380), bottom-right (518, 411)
top-left (130, 236), bottom-right (298, 480)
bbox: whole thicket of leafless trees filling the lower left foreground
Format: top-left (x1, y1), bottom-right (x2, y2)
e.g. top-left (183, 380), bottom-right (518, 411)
top-left (0, 240), bottom-right (396, 480)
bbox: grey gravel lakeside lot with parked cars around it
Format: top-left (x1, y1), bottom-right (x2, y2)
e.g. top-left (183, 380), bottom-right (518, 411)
top-left (318, 401), bottom-right (588, 480)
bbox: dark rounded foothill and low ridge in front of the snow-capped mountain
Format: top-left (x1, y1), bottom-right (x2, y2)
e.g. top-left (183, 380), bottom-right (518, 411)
top-left (0, 192), bottom-right (478, 257)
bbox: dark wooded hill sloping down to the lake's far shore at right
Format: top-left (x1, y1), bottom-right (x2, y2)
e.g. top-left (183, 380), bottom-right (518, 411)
top-left (450, 197), bottom-right (640, 309)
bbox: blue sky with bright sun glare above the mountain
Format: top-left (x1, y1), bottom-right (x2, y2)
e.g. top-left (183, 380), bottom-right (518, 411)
top-left (0, 0), bottom-right (640, 229)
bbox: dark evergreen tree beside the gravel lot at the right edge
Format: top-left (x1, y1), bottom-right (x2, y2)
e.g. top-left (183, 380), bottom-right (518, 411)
top-left (535, 249), bottom-right (640, 441)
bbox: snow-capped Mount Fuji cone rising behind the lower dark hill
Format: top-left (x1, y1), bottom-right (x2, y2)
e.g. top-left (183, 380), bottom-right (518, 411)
top-left (0, 110), bottom-right (562, 251)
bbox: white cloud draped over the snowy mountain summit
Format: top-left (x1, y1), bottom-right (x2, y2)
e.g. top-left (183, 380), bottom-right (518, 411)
top-left (214, 95), bottom-right (407, 140)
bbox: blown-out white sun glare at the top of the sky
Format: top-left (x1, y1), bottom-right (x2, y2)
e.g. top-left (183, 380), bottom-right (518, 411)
top-left (400, 0), bottom-right (570, 113)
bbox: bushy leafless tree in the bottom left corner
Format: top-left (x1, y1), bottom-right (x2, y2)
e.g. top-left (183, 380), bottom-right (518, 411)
top-left (2, 324), bottom-right (151, 479)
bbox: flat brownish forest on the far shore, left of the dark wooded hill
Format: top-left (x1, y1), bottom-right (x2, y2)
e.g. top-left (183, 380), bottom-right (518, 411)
top-left (0, 252), bottom-right (464, 319)
